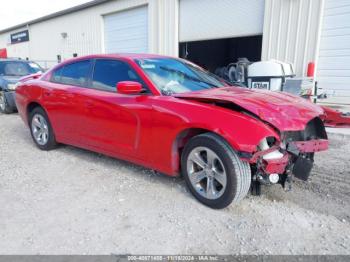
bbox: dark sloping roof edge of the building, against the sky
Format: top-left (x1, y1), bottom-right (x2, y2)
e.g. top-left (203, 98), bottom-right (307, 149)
top-left (0, 0), bottom-right (111, 34)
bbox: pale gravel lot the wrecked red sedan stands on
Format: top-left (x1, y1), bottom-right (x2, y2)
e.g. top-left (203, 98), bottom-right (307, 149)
top-left (0, 114), bottom-right (350, 254)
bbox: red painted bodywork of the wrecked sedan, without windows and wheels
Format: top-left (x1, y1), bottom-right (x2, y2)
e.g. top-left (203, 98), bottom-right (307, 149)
top-left (16, 55), bottom-right (323, 176)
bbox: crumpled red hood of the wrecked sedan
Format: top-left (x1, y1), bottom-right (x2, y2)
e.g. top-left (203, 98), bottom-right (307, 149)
top-left (174, 87), bottom-right (324, 131)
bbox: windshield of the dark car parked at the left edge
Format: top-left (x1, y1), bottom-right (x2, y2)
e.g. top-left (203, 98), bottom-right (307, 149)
top-left (0, 61), bottom-right (42, 76)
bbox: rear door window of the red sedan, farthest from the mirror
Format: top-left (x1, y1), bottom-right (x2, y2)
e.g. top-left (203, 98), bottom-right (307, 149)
top-left (52, 60), bottom-right (91, 86)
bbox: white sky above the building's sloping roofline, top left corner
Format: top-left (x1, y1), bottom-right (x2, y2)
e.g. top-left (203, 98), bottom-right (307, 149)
top-left (0, 0), bottom-right (91, 30)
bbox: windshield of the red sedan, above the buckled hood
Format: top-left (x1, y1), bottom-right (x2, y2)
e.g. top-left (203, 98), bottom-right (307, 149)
top-left (136, 58), bottom-right (227, 95)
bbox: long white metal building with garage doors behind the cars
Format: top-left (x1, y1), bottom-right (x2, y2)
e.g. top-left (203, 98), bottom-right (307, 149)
top-left (0, 0), bottom-right (350, 104)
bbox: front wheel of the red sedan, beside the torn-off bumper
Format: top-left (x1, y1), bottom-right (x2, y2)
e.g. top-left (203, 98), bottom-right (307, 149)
top-left (181, 133), bottom-right (251, 209)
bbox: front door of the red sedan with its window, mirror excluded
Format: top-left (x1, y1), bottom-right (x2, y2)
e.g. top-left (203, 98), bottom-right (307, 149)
top-left (79, 59), bottom-right (152, 159)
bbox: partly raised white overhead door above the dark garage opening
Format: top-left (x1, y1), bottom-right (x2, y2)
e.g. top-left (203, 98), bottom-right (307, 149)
top-left (179, 0), bottom-right (264, 42)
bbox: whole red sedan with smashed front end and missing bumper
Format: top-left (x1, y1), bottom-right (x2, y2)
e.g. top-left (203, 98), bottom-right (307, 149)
top-left (16, 54), bottom-right (328, 208)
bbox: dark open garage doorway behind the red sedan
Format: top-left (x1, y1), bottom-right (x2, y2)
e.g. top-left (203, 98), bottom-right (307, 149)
top-left (179, 35), bottom-right (262, 73)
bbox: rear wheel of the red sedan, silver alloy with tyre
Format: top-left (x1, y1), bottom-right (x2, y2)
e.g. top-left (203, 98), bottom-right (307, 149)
top-left (29, 107), bottom-right (57, 151)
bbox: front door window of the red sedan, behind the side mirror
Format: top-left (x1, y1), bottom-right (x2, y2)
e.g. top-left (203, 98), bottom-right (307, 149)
top-left (92, 59), bottom-right (145, 92)
